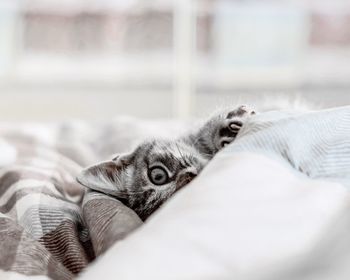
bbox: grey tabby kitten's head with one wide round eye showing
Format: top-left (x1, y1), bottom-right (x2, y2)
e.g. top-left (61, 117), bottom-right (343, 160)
top-left (77, 140), bottom-right (208, 220)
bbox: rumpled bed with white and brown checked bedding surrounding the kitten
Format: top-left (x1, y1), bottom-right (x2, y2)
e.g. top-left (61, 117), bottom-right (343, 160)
top-left (0, 107), bottom-right (350, 280)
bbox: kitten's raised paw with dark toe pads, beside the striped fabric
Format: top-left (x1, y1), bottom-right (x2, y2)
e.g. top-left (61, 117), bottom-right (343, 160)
top-left (217, 105), bottom-right (256, 149)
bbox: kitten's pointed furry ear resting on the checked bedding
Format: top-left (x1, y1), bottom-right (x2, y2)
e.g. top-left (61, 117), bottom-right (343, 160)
top-left (77, 155), bottom-right (132, 198)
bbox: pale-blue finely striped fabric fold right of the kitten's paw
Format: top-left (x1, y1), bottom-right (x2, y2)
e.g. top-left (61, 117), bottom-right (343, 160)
top-left (227, 106), bottom-right (350, 187)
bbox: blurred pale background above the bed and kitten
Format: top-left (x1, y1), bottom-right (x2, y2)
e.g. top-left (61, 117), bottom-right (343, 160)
top-left (0, 0), bottom-right (350, 121)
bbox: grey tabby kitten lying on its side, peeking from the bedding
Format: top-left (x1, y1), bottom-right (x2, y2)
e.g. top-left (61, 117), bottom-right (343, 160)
top-left (77, 106), bottom-right (255, 220)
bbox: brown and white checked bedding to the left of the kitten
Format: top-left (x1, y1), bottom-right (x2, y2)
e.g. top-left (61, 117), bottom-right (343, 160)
top-left (0, 120), bottom-right (171, 280)
